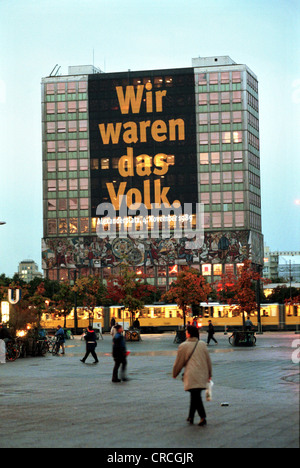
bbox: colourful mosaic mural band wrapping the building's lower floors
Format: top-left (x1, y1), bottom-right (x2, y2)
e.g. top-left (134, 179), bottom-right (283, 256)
top-left (42, 231), bottom-right (262, 270)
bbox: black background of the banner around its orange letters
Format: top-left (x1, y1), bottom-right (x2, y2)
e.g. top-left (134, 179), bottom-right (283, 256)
top-left (88, 68), bottom-right (198, 217)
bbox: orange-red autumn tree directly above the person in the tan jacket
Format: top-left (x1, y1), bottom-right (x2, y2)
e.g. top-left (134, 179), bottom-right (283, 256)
top-left (162, 268), bottom-right (212, 328)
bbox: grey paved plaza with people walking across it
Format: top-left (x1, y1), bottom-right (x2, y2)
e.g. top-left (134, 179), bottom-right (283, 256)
top-left (0, 332), bottom-right (300, 449)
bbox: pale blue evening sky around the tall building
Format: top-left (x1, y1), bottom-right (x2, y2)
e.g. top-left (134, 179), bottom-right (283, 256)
top-left (0, 0), bottom-right (300, 276)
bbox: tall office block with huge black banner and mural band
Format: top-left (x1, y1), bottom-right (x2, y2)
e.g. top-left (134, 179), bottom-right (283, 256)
top-left (42, 57), bottom-right (263, 287)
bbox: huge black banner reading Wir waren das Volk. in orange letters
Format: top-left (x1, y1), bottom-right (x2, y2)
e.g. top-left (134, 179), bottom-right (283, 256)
top-left (89, 69), bottom-right (198, 238)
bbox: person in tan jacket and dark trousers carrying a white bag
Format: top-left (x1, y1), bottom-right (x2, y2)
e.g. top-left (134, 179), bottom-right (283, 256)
top-left (173, 325), bottom-right (212, 426)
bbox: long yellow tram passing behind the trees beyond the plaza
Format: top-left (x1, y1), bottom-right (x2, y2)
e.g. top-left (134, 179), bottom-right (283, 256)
top-left (41, 302), bottom-right (300, 333)
